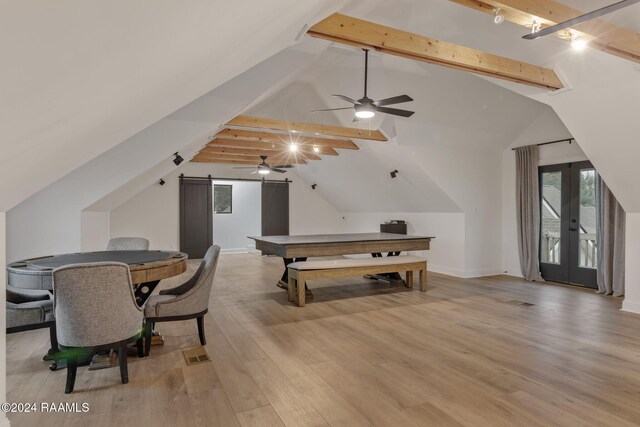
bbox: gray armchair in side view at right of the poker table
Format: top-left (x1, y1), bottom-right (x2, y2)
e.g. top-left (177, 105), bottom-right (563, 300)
top-left (144, 245), bottom-right (220, 356)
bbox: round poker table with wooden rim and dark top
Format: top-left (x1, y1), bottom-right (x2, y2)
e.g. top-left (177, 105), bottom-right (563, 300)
top-left (7, 251), bottom-right (188, 306)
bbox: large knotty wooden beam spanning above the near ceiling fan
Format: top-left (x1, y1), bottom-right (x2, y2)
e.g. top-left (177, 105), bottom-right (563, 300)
top-left (308, 13), bottom-right (563, 90)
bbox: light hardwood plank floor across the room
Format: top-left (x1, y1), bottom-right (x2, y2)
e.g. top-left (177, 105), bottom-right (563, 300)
top-left (7, 254), bottom-right (640, 427)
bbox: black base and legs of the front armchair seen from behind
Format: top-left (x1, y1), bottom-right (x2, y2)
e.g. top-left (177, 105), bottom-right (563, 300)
top-left (58, 333), bottom-right (144, 394)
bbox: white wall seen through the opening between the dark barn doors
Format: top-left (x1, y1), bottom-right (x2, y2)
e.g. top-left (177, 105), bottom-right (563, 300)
top-left (213, 181), bottom-right (262, 252)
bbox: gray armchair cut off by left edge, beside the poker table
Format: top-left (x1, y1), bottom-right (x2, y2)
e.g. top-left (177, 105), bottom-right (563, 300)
top-left (7, 285), bottom-right (58, 360)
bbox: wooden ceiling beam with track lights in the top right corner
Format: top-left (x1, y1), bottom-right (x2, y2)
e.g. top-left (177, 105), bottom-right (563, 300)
top-left (450, 0), bottom-right (640, 62)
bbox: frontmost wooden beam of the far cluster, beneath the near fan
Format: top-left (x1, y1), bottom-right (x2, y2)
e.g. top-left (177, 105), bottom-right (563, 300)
top-left (227, 116), bottom-right (387, 141)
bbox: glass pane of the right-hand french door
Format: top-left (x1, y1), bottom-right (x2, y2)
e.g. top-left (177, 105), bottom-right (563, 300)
top-left (578, 169), bottom-right (598, 268)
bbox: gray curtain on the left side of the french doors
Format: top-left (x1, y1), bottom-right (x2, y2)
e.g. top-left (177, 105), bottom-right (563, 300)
top-left (516, 145), bottom-right (543, 281)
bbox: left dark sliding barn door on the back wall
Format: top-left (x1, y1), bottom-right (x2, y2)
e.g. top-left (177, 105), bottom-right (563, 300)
top-left (180, 178), bottom-right (213, 259)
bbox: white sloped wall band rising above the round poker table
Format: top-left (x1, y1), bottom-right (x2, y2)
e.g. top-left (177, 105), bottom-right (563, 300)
top-left (7, 41), bottom-right (330, 261)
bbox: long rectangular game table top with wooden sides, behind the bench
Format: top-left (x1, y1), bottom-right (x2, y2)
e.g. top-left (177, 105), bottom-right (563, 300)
top-left (249, 233), bottom-right (433, 258)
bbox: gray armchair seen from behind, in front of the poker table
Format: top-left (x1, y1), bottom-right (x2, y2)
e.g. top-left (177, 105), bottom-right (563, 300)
top-left (53, 262), bottom-right (143, 393)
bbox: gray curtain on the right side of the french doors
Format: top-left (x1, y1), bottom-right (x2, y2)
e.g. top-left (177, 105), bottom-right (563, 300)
top-left (596, 175), bottom-right (625, 296)
